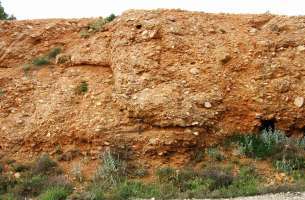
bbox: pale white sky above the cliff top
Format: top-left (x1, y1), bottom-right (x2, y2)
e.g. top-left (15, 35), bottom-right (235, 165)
top-left (0, 0), bottom-right (305, 19)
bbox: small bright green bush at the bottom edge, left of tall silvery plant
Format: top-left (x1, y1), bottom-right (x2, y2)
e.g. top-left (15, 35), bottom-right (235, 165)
top-left (39, 187), bottom-right (71, 200)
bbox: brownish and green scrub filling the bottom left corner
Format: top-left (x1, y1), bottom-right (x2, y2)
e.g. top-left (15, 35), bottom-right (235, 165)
top-left (0, 155), bottom-right (72, 200)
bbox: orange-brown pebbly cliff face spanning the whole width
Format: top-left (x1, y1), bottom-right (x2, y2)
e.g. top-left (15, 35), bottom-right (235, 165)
top-left (0, 10), bottom-right (305, 167)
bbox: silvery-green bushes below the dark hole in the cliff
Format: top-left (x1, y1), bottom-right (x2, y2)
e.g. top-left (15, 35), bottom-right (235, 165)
top-left (228, 129), bottom-right (305, 172)
